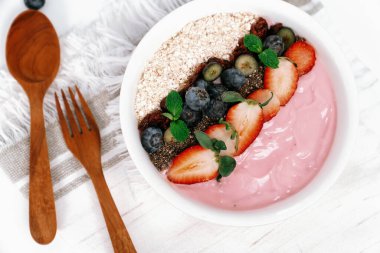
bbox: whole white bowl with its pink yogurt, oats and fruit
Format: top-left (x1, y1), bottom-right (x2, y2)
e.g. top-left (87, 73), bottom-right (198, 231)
top-left (121, 1), bottom-right (353, 225)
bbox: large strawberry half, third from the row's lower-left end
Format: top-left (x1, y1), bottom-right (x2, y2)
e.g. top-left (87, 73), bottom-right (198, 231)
top-left (226, 102), bottom-right (264, 155)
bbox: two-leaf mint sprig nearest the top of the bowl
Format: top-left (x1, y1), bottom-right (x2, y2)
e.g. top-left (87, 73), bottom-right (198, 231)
top-left (243, 34), bottom-right (280, 69)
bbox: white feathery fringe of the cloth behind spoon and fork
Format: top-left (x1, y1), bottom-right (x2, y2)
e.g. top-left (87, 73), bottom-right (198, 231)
top-left (0, 0), bottom-right (188, 148)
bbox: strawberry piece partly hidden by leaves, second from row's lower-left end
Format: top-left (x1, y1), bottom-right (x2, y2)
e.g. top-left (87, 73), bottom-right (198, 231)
top-left (205, 124), bottom-right (236, 156)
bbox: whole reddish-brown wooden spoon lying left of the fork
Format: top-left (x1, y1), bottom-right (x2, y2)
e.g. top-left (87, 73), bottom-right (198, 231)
top-left (6, 10), bottom-right (60, 244)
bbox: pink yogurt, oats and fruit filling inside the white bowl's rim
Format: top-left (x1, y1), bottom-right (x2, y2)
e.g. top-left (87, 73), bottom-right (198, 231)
top-left (135, 12), bottom-right (336, 209)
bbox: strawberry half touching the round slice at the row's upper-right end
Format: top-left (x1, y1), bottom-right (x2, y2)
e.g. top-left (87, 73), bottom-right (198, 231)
top-left (264, 58), bottom-right (298, 105)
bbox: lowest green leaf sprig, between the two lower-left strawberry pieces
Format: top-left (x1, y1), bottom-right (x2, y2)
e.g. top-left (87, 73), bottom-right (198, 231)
top-left (194, 131), bottom-right (236, 182)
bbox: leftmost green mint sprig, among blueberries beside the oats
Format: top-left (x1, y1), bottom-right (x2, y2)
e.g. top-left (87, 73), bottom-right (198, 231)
top-left (162, 91), bottom-right (190, 142)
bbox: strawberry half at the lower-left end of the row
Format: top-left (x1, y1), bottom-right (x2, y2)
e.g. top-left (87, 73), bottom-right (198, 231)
top-left (167, 145), bottom-right (218, 184)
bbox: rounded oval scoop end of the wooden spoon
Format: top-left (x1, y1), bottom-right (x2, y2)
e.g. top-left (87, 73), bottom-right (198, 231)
top-left (6, 10), bottom-right (60, 90)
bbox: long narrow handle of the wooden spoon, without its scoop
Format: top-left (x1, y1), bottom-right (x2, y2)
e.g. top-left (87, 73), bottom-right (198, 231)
top-left (29, 96), bottom-right (57, 244)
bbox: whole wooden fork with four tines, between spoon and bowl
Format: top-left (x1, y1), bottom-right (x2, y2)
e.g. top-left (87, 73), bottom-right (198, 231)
top-left (55, 86), bottom-right (136, 253)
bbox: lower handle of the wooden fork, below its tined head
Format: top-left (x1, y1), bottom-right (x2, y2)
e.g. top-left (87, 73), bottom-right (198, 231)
top-left (91, 170), bottom-right (136, 253)
